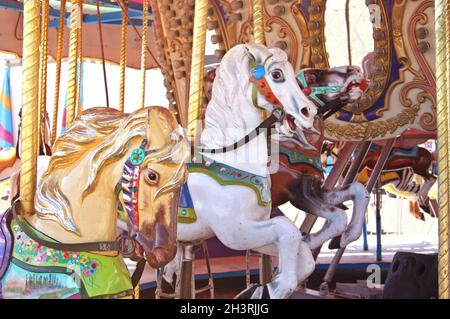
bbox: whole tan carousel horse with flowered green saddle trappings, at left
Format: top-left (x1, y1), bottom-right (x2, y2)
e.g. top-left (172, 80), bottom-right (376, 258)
top-left (0, 107), bottom-right (189, 298)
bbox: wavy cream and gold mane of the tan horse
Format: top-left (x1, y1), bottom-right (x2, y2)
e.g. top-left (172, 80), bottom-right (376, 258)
top-left (35, 108), bottom-right (153, 233)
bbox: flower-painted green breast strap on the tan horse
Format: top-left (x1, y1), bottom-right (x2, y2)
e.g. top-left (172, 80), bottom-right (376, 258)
top-left (11, 221), bottom-right (132, 298)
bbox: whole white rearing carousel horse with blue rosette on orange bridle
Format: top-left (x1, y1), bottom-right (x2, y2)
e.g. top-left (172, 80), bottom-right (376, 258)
top-left (165, 44), bottom-right (317, 298)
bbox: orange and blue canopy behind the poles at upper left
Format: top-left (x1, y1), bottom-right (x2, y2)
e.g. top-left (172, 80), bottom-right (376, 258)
top-left (0, 0), bottom-right (158, 68)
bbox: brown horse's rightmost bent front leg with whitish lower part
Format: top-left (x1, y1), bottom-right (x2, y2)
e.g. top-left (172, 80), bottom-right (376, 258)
top-left (321, 183), bottom-right (370, 248)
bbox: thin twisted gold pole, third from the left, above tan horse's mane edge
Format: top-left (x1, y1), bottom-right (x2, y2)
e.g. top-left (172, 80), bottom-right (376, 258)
top-left (52, 0), bottom-right (66, 143)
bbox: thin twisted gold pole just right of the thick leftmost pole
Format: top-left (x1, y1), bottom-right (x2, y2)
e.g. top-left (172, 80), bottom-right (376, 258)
top-left (37, 0), bottom-right (50, 151)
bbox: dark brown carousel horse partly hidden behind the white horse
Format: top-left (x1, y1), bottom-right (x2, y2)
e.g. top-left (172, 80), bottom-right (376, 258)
top-left (271, 66), bottom-right (369, 249)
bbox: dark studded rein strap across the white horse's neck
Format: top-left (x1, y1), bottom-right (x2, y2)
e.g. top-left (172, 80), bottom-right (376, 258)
top-left (192, 108), bottom-right (284, 154)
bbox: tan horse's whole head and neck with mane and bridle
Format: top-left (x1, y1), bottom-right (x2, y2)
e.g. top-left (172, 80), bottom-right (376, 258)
top-left (34, 106), bottom-right (189, 268)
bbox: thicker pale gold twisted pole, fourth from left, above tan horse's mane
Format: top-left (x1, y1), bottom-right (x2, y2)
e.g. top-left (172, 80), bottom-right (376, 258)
top-left (66, 0), bottom-right (82, 128)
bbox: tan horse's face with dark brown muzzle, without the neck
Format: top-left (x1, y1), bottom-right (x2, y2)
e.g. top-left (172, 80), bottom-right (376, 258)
top-left (128, 109), bottom-right (189, 268)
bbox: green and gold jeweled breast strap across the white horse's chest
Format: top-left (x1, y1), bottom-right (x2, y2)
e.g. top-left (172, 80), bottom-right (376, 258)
top-left (188, 158), bottom-right (271, 206)
